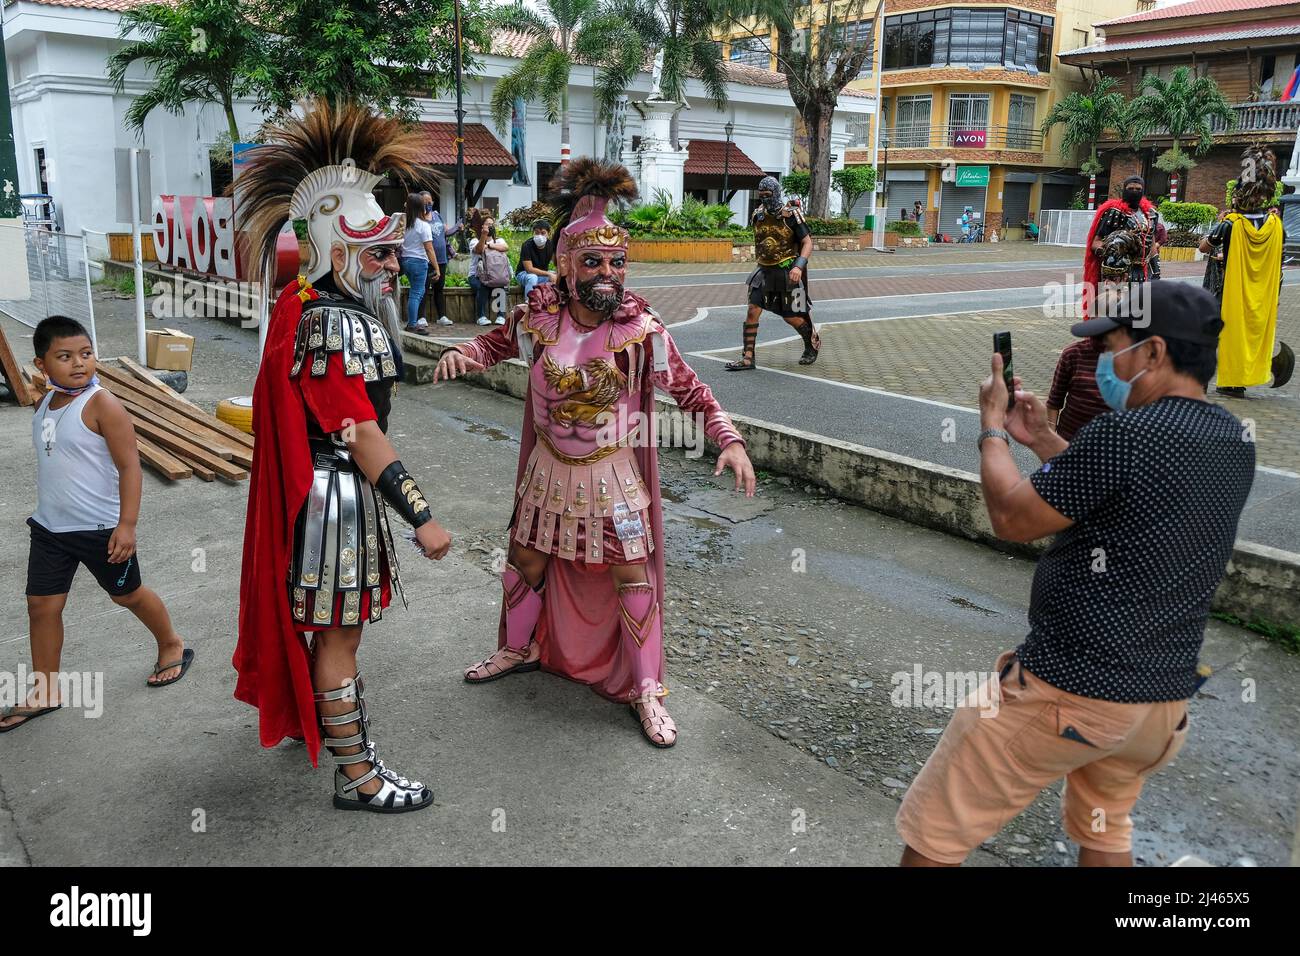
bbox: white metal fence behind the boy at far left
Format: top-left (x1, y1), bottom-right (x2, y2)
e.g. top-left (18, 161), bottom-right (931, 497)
top-left (0, 225), bottom-right (100, 339)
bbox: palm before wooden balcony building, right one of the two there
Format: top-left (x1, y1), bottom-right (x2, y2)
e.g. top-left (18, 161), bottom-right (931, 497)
top-left (1128, 66), bottom-right (1236, 203)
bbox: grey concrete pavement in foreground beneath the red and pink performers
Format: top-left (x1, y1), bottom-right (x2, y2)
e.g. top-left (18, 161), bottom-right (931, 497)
top-left (0, 257), bottom-right (1300, 866)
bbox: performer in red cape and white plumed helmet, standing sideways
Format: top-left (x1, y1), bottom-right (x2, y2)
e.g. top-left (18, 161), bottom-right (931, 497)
top-left (234, 101), bottom-right (451, 813)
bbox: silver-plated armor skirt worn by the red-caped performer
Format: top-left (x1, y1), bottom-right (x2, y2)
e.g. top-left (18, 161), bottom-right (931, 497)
top-left (289, 438), bottom-right (402, 630)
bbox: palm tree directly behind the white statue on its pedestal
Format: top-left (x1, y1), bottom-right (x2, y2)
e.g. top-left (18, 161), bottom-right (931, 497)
top-left (611, 0), bottom-right (735, 150)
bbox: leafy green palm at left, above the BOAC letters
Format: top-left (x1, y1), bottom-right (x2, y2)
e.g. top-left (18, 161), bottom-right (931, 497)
top-left (108, 0), bottom-right (265, 142)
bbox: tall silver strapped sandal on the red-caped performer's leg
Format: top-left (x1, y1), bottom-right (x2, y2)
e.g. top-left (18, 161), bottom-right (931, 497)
top-left (312, 674), bottom-right (433, 813)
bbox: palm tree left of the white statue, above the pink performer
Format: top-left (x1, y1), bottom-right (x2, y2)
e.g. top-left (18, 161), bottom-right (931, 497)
top-left (491, 0), bottom-right (645, 163)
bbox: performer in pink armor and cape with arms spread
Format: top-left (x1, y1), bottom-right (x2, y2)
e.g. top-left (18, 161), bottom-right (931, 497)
top-left (434, 157), bottom-right (754, 748)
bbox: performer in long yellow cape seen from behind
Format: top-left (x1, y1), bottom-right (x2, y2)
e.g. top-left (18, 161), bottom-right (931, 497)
top-left (1201, 147), bottom-right (1295, 398)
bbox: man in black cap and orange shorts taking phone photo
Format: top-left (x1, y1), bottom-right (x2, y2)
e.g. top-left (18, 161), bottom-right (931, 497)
top-left (896, 282), bottom-right (1255, 866)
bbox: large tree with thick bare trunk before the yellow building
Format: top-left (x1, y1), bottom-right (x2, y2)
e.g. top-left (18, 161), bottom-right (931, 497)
top-left (727, 0), bottom-right (883, 216)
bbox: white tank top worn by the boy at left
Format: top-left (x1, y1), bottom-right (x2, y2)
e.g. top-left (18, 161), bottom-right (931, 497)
top-left (31, 385), bottom-right (120, 532)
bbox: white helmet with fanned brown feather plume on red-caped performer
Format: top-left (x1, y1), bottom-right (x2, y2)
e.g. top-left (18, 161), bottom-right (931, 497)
top-left (231, 99), bottom-right (426, 295)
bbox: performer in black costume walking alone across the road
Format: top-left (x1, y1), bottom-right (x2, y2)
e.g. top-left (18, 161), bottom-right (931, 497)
top-left (725, 176), bottom-right (822, 372)
